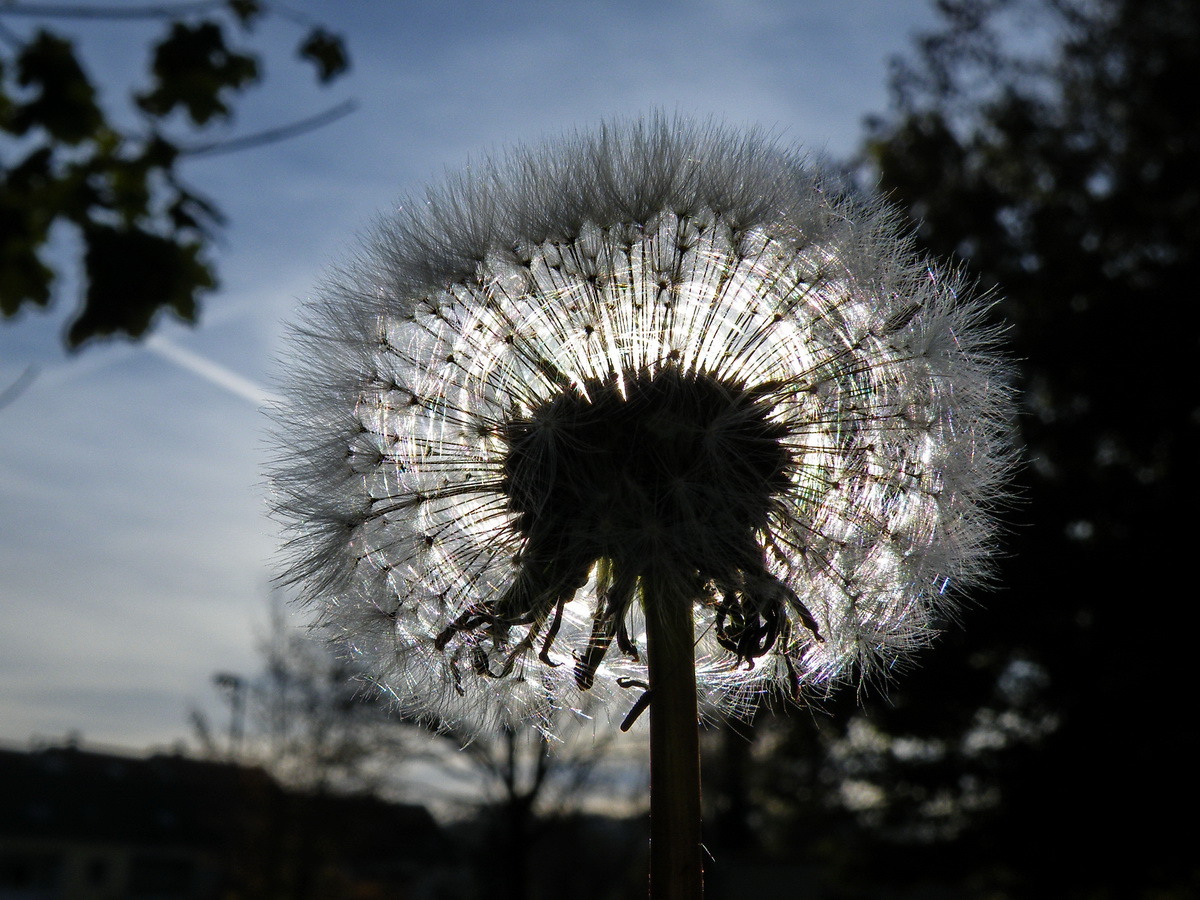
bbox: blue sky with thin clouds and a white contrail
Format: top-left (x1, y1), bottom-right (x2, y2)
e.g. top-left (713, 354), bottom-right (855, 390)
top-left (0, 0), bottom-right (934, 748)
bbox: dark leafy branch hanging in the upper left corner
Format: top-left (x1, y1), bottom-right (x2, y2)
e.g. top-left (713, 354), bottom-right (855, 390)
top-left (0, 0), bottom-right (348, 349)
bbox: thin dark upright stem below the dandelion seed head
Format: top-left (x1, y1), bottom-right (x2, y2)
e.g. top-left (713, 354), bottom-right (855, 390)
top-left (643, 578), bottom-right (703, 900)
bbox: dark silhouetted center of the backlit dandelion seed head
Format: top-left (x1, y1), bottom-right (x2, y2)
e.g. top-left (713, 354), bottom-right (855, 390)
top-left (503, 366), bottom-right (792, 575)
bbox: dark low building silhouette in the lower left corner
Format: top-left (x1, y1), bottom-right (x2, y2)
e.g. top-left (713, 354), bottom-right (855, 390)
top-left (0, 745), bottom-right (454, 900)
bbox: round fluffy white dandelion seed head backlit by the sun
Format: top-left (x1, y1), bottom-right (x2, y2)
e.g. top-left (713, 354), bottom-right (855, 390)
top-left (275, 118), bottom-right (1009, 895)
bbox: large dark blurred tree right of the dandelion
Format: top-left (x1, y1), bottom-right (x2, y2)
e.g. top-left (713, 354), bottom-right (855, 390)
top-left (706, 0), bottom-right (1200, 900)
